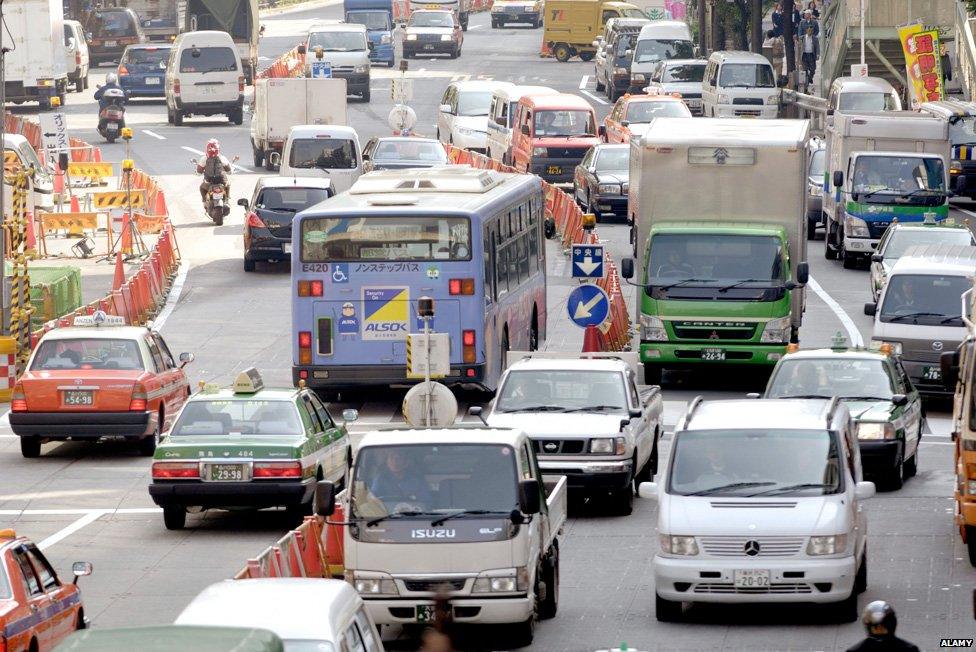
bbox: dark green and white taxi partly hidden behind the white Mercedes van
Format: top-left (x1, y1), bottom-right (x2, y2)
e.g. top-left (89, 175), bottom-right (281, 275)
top-left (765, 335), bottom-right (923, 489)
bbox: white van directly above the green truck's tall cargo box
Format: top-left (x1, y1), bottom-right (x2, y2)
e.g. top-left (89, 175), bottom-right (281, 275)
top-left (702, 51), bottom-right (779, 118)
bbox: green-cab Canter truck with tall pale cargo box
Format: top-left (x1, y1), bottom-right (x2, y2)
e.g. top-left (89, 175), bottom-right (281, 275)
top-left (622, 118), bottom-right (809, 384)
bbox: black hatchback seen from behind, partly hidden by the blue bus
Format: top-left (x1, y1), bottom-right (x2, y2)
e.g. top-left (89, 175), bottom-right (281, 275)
top-left (237, 177), bottom-right (335, 272)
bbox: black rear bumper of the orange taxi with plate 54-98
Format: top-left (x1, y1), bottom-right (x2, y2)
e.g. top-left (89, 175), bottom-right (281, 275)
top-left (10, 411), bottom-right (159, 440)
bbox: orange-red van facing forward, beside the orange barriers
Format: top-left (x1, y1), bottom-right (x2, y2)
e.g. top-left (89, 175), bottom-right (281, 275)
top-left (512, 93), bottom-right (601, 184)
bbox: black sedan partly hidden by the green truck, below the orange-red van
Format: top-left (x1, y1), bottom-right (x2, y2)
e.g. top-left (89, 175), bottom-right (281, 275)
top-left (573, 144), bottom-right (630, 221)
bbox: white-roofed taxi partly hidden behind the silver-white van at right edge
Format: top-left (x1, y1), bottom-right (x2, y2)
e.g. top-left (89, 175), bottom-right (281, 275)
top-left (869, 213), bottom-right (976, 303)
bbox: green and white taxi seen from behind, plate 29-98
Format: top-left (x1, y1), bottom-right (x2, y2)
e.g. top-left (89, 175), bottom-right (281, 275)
top-left (149, 369), bottom-right (358, 530)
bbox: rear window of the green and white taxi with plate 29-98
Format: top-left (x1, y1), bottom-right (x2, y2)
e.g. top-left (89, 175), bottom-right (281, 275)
top-left (172, 399), bottom-right (305, 437)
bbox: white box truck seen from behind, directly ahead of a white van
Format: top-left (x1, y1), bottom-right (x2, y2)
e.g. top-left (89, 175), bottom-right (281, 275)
top-left (251, 77), bottom-right (347, 171)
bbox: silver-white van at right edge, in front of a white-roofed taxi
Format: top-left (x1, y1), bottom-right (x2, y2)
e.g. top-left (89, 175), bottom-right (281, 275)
top-left (864, 245), bottom-right (976, 396)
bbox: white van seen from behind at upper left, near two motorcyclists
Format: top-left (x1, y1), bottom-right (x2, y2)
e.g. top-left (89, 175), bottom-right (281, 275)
top-left (166, 31), bottom-right (244, 127)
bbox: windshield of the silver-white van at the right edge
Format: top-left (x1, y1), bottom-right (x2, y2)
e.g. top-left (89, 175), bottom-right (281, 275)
top-left (880, 274), bottom-right (972, 326)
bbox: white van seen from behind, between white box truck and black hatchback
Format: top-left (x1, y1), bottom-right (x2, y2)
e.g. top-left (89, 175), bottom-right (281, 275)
top-left (280, 125), bottom-right (363, 193)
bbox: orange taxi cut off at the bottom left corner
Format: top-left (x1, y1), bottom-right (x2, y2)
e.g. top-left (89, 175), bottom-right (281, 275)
top-left (0, 530), bottom-right (92, 652)
